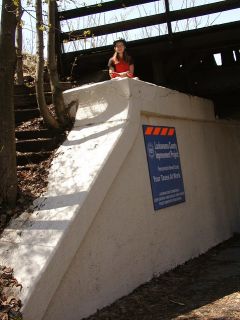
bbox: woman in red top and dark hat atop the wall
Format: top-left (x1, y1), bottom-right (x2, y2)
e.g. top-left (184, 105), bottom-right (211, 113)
top-left (108, 39), bottom-right (134, 79)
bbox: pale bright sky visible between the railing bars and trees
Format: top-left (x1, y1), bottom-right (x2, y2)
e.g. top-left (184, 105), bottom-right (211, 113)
top-left (0, 0), bottom-right (240, 53)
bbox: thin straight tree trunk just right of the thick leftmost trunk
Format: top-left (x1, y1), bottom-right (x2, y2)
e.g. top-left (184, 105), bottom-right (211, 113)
top-left (16, 0), bottom-right (23, 84)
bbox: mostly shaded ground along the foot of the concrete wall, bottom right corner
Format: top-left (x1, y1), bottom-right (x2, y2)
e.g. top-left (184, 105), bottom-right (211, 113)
top-left (85, 234), bottom-right (240, 320)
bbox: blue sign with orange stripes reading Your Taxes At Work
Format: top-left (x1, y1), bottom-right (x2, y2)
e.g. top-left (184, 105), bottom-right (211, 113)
top-left (143, 125), bottom-right (185, 210)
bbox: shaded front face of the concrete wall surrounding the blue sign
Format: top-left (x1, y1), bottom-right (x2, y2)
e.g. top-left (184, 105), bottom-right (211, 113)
top-left (44, 79), bottom-right (240, 320)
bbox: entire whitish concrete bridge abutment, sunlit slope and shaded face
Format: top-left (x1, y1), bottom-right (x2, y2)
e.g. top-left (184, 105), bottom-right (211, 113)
top-left (0, 79), bottom-right (240, 320)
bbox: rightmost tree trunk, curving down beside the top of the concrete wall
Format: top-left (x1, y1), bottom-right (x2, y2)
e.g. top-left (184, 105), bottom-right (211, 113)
top-left (48, 0), bottom-right (70, 127)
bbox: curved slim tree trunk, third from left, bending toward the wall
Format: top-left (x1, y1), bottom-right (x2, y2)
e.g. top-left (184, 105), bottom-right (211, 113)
top-left (35, 0), bottom-right (59, 129)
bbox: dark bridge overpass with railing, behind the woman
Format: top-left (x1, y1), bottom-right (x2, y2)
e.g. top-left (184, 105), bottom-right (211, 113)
top-left (56, 0), bottom-right (240, 119)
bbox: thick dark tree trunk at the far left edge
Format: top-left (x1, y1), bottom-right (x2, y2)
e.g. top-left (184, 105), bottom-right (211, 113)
top-left (0, 0), bottom-right (17, 207)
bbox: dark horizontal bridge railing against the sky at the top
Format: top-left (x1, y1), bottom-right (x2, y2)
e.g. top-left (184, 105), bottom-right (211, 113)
top-left (57, 0), bottom-right (240, 53)
